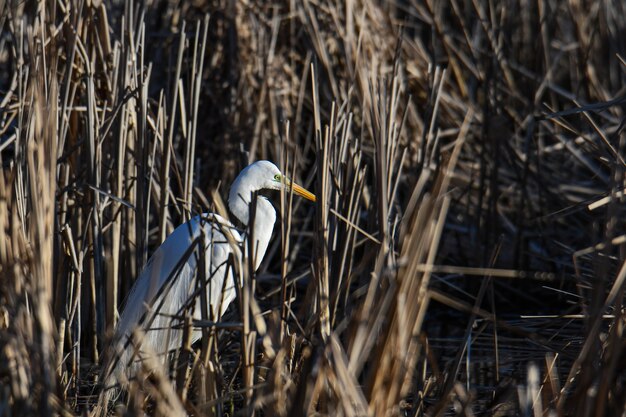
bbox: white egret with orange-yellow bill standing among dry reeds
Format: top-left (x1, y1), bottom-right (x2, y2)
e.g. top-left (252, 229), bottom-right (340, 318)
top-left (103, 161), bottom-right (315, 396)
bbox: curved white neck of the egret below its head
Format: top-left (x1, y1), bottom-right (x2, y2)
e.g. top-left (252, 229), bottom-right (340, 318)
top-left (228, 184), bottom-right (276, 270)
